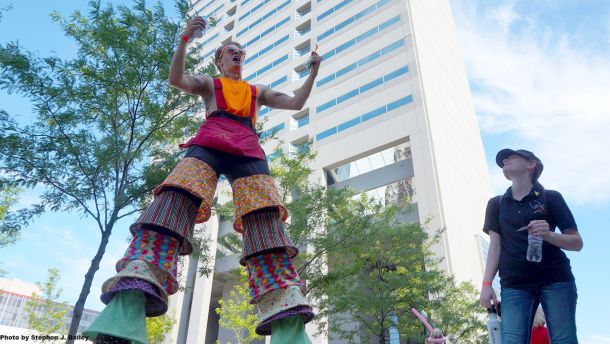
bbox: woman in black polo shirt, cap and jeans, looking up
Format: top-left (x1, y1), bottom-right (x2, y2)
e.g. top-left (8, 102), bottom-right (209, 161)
top-left (480, 149), bottom-right (583, 344)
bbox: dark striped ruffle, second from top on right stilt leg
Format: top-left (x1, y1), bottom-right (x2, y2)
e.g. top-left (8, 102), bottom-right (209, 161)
top-left (239, 210), bottom-right (299, 266)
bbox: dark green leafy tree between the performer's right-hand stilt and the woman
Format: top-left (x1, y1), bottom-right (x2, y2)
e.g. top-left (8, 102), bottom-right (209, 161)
top-left (314, 204), bottom-right (484, 343)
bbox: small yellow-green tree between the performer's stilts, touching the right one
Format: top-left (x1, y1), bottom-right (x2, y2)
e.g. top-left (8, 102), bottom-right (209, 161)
top-left (215, 267), bottom-right (263, 344)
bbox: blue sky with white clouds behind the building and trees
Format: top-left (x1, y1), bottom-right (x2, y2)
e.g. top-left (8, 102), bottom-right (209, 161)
top-left (0, 0), bottom-right (610, 344)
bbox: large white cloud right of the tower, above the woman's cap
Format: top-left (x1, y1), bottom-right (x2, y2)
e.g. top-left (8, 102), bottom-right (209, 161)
top-left (453, 1), bottom-right (610, 203)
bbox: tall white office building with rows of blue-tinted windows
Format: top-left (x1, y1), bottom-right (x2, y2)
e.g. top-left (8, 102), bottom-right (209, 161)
top-left (172, 0), bottom-right (491, 343)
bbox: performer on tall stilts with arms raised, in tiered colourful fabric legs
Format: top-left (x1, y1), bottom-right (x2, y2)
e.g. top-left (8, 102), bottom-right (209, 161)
top-left (84, 17), bottom-right (321, 344)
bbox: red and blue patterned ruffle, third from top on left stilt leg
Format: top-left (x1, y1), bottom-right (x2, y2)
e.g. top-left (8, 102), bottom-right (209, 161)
top-left (116, 228), bottom-right (178, 295)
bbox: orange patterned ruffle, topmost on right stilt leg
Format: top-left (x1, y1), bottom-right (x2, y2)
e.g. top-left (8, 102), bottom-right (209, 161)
top-left (231, 174), bottom-right (288, 233)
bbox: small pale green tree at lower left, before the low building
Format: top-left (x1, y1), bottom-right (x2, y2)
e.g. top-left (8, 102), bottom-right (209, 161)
top-left (25, 268), bottom-right (70, 343)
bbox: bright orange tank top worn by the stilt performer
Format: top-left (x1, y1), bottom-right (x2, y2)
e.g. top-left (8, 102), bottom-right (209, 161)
top-left (215, 77), bottom-right (257, 127)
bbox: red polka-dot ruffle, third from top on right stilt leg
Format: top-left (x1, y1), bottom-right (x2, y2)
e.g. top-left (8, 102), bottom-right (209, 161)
top-left (246, 252), bottom-right (304, 303)
